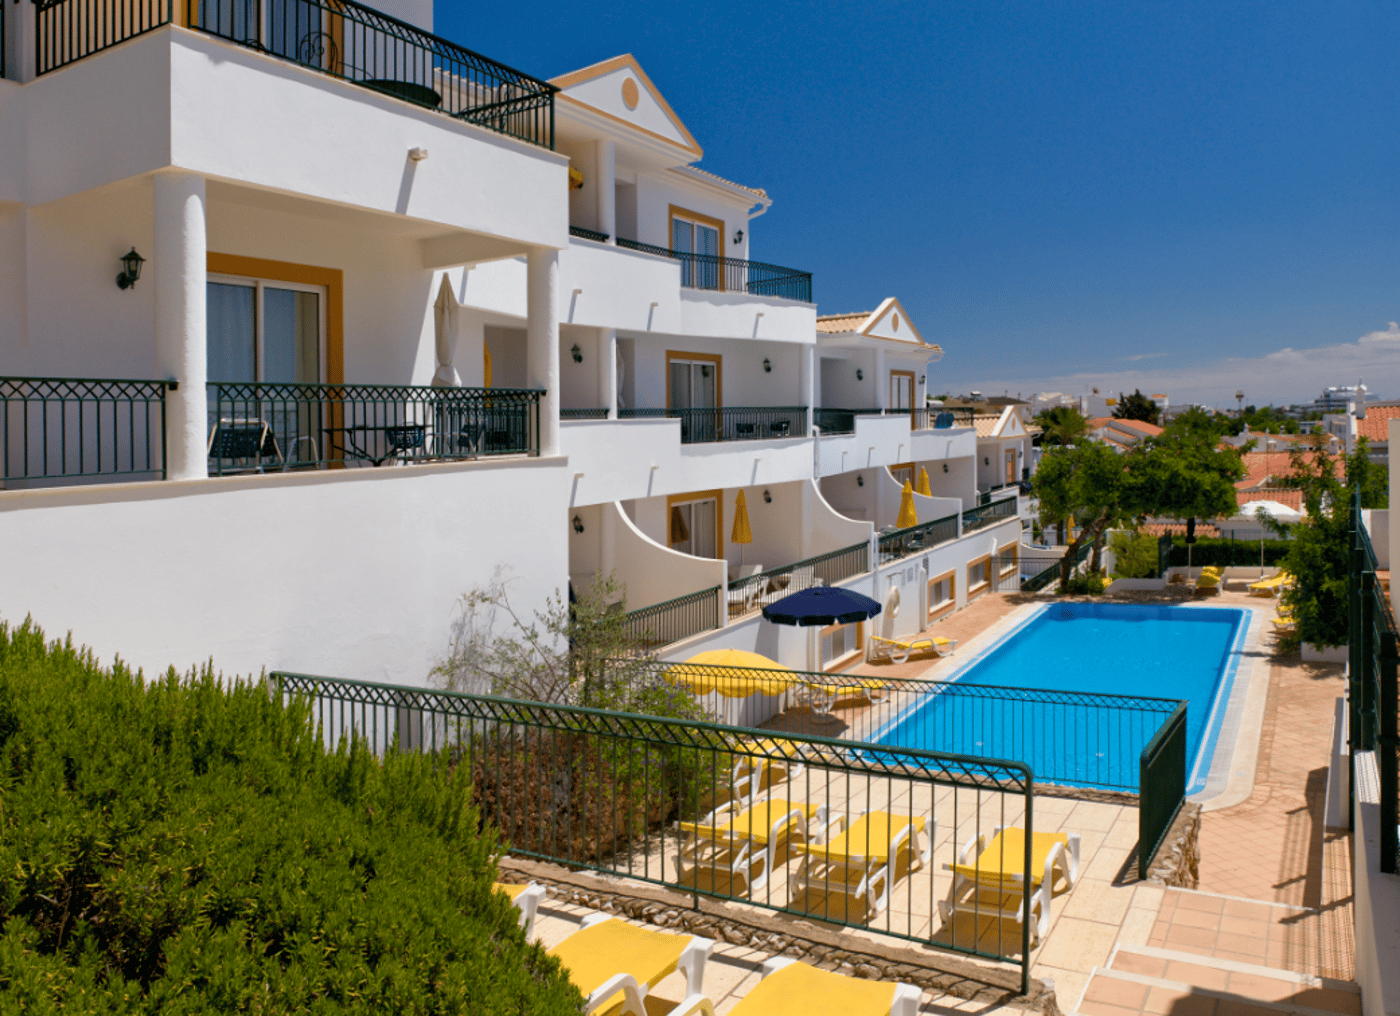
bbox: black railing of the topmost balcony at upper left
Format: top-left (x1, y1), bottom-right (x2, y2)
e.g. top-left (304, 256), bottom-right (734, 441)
top-left (36, 0), bottom-right (559, 148)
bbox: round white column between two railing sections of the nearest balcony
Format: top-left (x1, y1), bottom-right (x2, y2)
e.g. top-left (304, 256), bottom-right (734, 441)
top-left (150, 172), bottom-right (209, 480)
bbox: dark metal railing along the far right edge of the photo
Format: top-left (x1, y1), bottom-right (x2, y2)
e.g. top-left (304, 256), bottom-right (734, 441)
top-left (1347, 487), bottom-right (1400, 875)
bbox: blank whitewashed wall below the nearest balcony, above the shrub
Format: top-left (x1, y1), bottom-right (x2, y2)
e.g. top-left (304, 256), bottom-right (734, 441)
top-left (0, 459), bottom-right (568, 684)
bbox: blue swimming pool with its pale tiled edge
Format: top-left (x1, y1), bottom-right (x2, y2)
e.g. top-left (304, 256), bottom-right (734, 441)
top-left (871, 600), bottom-right (1264, 806)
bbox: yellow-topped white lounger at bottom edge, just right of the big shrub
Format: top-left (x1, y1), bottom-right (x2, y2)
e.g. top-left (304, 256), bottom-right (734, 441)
top-left (549, 914), bottom-right (714, 1016)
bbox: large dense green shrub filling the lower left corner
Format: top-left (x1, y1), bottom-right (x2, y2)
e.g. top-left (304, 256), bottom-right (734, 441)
top-left (0, 623), bottom-right (582, 1013)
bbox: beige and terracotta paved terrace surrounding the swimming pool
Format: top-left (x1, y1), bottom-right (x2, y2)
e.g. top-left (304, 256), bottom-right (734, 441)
top-left (506, 588), bottom-right (1359, 1016)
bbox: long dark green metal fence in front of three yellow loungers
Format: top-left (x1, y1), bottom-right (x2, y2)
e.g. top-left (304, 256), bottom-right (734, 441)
top-left (269, 673), bottom-right (1036, 992)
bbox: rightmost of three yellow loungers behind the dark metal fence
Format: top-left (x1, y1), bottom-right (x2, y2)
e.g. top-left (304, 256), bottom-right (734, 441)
top-left (938, 826), bottom-right (1079, 942)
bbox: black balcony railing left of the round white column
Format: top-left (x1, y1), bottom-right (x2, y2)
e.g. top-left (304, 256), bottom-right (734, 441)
top-left (0, 378), bottom-right (175, 487)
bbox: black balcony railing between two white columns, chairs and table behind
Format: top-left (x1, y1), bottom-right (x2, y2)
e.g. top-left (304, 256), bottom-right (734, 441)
top-left (209, 381), bottom-right (543, 476)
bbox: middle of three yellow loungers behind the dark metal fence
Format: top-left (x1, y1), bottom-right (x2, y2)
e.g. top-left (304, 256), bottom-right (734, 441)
top-left (794, 812), bottom-right (938, 917)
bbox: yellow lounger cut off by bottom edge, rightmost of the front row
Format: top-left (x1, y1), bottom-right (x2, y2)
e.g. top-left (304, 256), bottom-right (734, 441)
top-left (671, 956), bottom-right (923, 1016)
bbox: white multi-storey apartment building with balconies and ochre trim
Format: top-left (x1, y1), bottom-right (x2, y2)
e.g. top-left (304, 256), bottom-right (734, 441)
top-left (0, 0), bottom-right (1022, 683)
